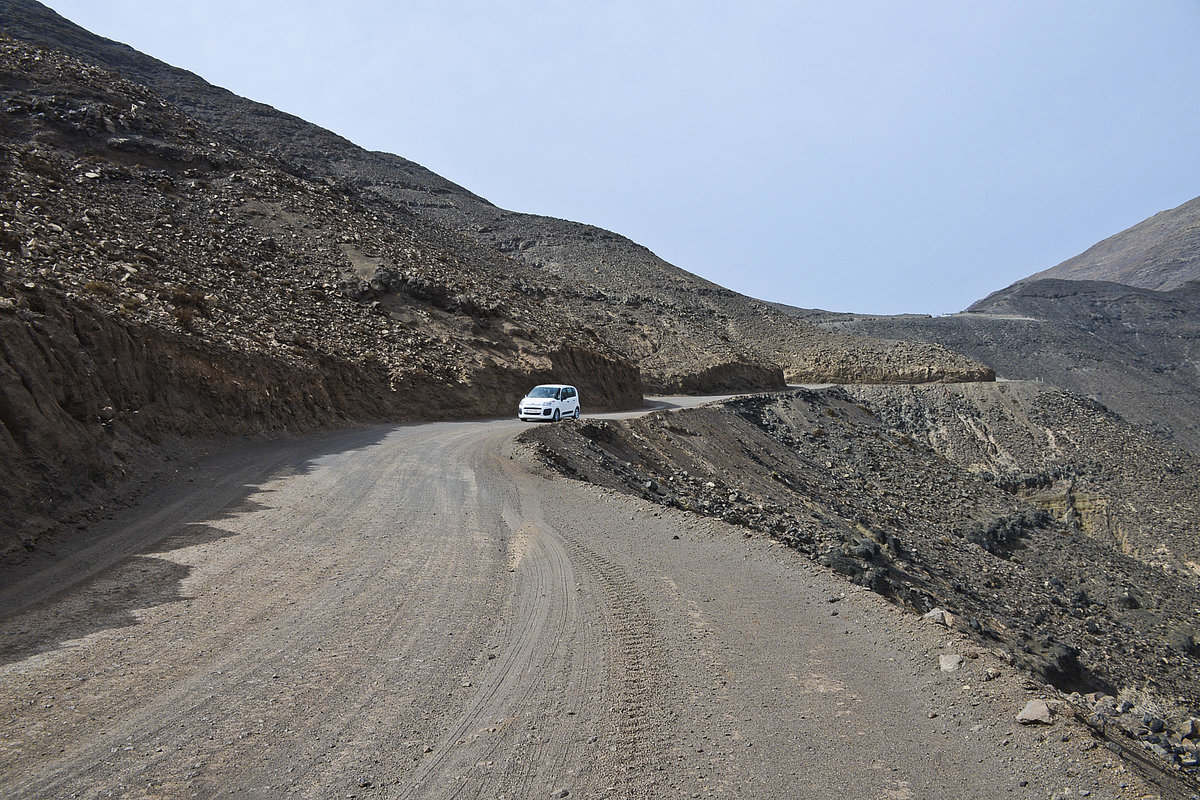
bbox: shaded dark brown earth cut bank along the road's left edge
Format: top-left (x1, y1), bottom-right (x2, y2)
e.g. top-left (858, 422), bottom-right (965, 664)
top-left (0, 291), bottom-right (379, 555)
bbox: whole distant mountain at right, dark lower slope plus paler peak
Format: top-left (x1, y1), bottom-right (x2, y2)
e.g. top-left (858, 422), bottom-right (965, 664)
top-left (780, 190), bottom-right (1200, 452)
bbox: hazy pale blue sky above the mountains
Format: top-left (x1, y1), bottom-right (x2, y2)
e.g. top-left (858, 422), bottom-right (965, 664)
top-left (37, 0), bottom-right (1200, 314)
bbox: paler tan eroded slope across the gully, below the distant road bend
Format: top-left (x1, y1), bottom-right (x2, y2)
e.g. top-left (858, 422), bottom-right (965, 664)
top-left (847, 383), bottom-right (1200, 578)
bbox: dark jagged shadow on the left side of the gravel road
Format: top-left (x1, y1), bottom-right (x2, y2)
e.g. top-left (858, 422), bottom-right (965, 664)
top-left (0, 426), bottom-right (395, 664)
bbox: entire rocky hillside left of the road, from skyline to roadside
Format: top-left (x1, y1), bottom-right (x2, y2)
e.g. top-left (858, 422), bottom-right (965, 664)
top-left (0, 0), bottom-right (991, 563)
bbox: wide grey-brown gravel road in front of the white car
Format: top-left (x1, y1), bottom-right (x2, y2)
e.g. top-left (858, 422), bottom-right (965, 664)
top-left (0, 400), bottom-right (1161, 799)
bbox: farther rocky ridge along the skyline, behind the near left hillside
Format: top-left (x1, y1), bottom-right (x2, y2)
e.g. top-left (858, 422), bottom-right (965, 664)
top-left (0, 0), bottom-right (990, 391)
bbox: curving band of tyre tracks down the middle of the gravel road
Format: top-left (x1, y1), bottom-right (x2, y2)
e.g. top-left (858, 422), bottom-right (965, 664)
top-left (396, 431), bottom-right (656, 798)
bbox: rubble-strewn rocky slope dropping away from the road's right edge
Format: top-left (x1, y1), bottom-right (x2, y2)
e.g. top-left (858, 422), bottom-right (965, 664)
top-left (524, 384), bottom-right (1200, 771)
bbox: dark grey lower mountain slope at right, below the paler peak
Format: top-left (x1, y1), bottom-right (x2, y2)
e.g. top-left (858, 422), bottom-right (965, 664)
top-left (793, 279), bottom-right (1200, 452)
